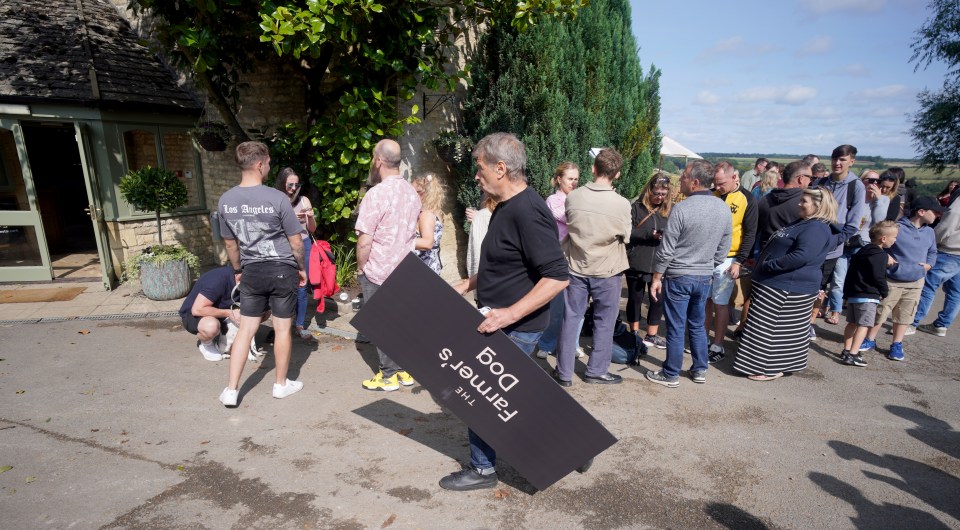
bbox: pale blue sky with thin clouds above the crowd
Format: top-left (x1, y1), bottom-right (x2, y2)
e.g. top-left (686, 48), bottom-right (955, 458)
top-left (630, 0), bottom-right (947, 158)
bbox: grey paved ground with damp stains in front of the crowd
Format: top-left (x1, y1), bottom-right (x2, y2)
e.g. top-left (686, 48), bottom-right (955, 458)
top-left (0, 282), bottom-right (960, 529)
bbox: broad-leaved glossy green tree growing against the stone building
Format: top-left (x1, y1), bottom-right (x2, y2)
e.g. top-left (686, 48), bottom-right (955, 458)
top-left (130, 0), bottom-right (588, 239)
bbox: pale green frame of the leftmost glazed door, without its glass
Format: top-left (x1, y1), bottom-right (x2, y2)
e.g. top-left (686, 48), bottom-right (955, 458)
top-left (0, 118), bottom-right (53, 282)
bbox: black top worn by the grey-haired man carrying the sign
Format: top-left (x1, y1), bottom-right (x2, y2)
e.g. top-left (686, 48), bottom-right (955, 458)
top-left (477, 186), bottom-right (569, 331)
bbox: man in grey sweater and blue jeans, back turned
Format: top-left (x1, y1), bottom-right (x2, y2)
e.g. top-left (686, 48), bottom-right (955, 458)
top-left (647, 160), bottom-right (733, 388)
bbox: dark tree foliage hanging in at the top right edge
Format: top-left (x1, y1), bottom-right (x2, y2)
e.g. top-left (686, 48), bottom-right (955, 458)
top-left (910, 0), bottom-right (960, 173)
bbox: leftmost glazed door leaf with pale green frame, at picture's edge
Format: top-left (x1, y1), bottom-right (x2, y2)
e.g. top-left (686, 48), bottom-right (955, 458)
top-left (0, 118), bottom-right (53, 282)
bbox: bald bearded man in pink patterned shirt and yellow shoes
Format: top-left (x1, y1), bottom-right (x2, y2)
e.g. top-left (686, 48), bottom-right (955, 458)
top-left (355, 140), bottom-right (420, 392)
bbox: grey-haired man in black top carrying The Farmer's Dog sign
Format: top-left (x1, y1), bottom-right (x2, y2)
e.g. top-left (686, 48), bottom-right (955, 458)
top-left (440, 133), bottom-right (569, 491)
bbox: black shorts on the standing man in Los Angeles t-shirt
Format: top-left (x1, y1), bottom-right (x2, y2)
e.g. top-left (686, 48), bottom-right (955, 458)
top-left (240, 262), bottom-right (300, 318)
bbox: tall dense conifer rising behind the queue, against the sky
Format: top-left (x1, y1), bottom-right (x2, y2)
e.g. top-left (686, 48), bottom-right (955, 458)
top-left (458, 0), bottom-right (660, 206)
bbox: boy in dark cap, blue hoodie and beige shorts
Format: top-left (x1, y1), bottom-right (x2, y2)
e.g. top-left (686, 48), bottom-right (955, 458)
top-left (860, 197), bottom-right (943, 361)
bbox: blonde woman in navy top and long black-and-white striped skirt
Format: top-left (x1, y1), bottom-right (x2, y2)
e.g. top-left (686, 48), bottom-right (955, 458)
top-left (733, 186), bottom-right (841, 381)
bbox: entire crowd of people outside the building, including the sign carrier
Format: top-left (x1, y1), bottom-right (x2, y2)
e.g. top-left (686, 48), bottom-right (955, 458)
top-left (181, 133), bottom-right (960, 490)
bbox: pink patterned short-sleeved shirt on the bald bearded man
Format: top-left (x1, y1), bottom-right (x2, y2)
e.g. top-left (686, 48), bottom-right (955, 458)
top-left (355, 175), bottom-right (420, 285)
